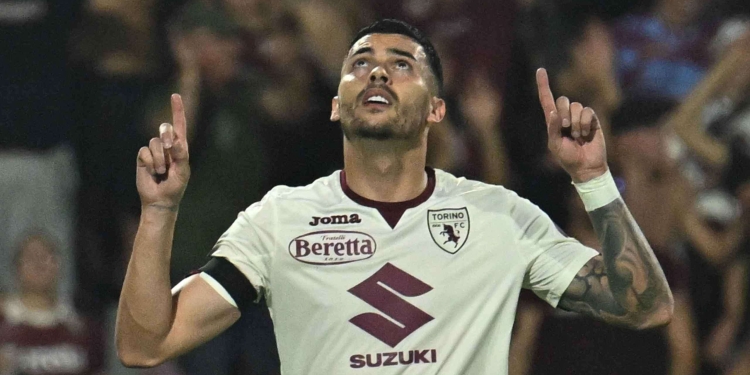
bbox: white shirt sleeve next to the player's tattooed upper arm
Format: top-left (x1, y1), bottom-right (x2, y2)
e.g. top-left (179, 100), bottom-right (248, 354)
top-left (512, 198), bottom-right (599, 307)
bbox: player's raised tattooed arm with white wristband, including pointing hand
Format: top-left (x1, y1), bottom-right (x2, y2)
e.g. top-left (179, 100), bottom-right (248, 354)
top-left (537, 69), bottom-right (674, 329)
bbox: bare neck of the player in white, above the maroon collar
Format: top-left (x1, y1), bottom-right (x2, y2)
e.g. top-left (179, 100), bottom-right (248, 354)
top-left (344, 134), bottom-right (427, 202)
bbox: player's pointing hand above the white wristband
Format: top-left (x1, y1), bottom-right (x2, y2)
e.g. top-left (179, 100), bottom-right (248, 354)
top-left (536, 68), bottom-right (607, 183)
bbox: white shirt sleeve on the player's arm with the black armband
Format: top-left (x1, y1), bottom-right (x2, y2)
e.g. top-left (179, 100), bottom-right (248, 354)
top-left (211, 197), bottom-right (273, 297)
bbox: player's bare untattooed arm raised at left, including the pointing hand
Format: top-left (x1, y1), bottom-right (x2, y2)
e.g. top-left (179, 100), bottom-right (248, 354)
top-left (116, 95), bottom-right (240, 367)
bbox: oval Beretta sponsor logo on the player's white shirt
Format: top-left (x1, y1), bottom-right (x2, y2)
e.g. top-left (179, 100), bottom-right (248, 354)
top-left (289, 230), bottom-right (376, 265)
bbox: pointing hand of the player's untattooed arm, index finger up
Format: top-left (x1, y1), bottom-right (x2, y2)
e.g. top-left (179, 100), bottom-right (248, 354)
top-left (136, 94), bottom-right (190, 211)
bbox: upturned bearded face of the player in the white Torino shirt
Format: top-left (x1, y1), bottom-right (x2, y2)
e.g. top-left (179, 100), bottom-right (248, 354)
top-left (331, 34), bottom-right (444, 140)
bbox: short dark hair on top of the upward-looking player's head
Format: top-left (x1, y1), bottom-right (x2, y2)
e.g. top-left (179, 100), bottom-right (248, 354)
top-left (349, 18), bottom-right (443, 96)
